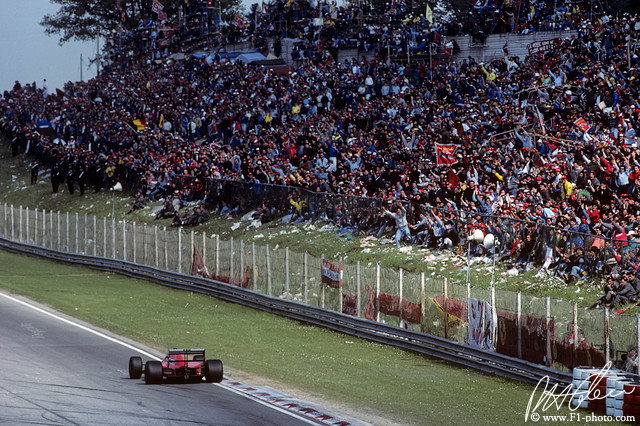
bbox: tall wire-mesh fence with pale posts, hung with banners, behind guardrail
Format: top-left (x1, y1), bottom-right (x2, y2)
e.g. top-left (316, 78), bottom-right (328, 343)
top-left (0, 204), bottom-right (639, 370)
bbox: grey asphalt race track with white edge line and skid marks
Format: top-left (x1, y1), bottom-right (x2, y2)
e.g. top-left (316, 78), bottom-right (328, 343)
top-left (0, 293), bottom-right (330, 426)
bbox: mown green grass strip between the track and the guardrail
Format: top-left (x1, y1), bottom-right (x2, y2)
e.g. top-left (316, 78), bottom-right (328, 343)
top-left (0, 251), bottom-right (620, 425)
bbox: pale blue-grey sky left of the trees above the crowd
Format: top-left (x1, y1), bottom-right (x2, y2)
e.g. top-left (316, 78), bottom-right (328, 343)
top-left (0, 0), bottom-right (96, 93)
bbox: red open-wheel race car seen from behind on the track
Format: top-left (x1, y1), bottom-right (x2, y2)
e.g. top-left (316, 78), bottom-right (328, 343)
top-left (129, 349), bottom-right (223, 384)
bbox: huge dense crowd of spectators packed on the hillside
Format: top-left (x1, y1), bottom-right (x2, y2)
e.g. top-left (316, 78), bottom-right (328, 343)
top-left (0, 2), bottom-right (640, 306)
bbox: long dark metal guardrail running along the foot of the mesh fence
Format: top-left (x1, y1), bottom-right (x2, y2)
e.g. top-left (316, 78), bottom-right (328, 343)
top-left (0, 238), bottom-right (572, 386)
